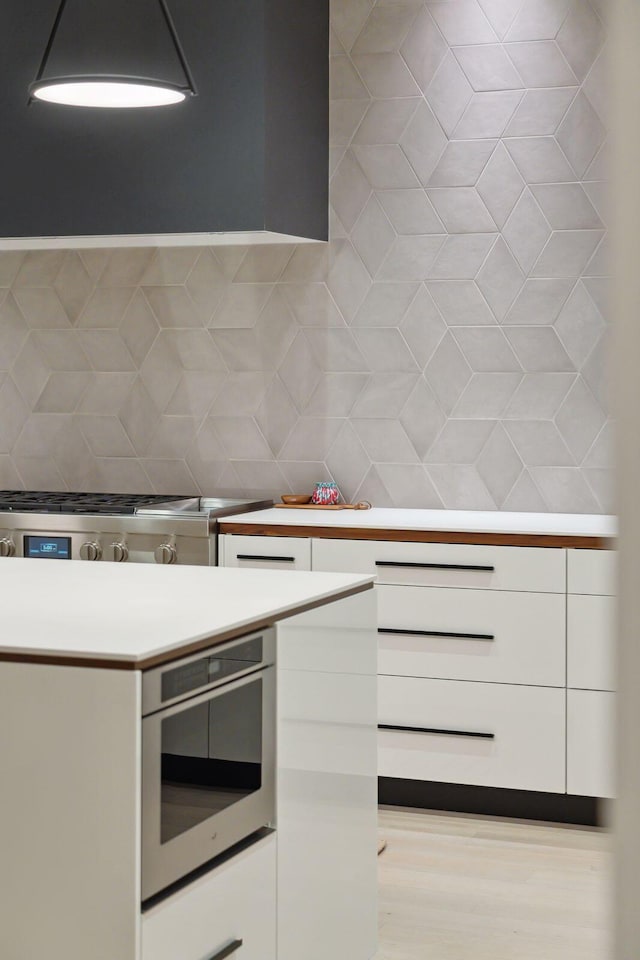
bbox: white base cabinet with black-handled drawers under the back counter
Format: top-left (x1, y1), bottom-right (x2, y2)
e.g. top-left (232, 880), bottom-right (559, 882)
top-left (221, 535), bottom-right (616, 798)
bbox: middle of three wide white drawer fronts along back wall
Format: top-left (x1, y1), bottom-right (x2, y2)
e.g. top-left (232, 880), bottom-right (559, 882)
top-left (376, 584), bottom-right (566, 687)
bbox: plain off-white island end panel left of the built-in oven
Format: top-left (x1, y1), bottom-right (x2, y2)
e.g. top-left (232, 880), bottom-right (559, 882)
top-left (0, 660), bottom-right (140, 960)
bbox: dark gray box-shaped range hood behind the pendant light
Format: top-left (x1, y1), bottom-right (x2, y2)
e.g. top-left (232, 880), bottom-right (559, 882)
top-left (0, 0), bottom-right (329, 247)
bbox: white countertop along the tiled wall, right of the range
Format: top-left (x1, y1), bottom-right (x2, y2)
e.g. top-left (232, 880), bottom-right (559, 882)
top-left (221, 507), bottom-right (617, 537)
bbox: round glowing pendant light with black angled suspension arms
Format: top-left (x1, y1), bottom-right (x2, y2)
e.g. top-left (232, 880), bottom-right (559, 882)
top-left (29, 0), bottom-right (197, 108)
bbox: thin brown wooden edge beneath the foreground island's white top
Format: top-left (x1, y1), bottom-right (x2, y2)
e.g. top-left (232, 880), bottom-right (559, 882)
top-left (0, 581), bottom-right (373, 670)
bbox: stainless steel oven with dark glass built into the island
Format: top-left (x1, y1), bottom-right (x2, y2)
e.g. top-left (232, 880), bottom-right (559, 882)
top-left (142, 628), bottom-right (276, 900)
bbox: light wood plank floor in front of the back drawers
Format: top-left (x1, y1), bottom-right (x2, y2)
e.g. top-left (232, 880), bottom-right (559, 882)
top-left (376, 807), bottom-right (611, 960)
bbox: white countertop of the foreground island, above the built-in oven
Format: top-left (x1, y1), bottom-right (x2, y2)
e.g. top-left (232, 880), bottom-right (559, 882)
top-left (0, 560), bottom-right (373, 664)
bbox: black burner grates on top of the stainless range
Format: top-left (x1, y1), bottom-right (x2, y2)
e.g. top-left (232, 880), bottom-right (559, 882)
top-left (0, 490), bottom-right (189, 515)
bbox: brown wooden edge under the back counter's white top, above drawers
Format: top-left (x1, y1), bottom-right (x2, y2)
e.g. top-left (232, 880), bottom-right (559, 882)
top-left (220, 521), bottom-right (615, 550)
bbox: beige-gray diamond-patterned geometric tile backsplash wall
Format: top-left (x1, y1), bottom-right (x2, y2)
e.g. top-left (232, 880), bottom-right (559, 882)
top-left (0, 0), bottom-right (613, 513)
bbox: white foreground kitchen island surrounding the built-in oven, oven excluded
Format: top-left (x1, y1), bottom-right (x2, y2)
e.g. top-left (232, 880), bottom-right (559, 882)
top-left (0, 559), bottom-right (377, 960)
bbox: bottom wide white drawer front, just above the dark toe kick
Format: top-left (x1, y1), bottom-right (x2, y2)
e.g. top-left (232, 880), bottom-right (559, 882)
top-left (378, 677), bottom-right (566, 793)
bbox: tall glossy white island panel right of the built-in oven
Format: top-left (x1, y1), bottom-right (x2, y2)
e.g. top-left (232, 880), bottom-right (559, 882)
top-left (277, 590), bottom-right (378, 960)
